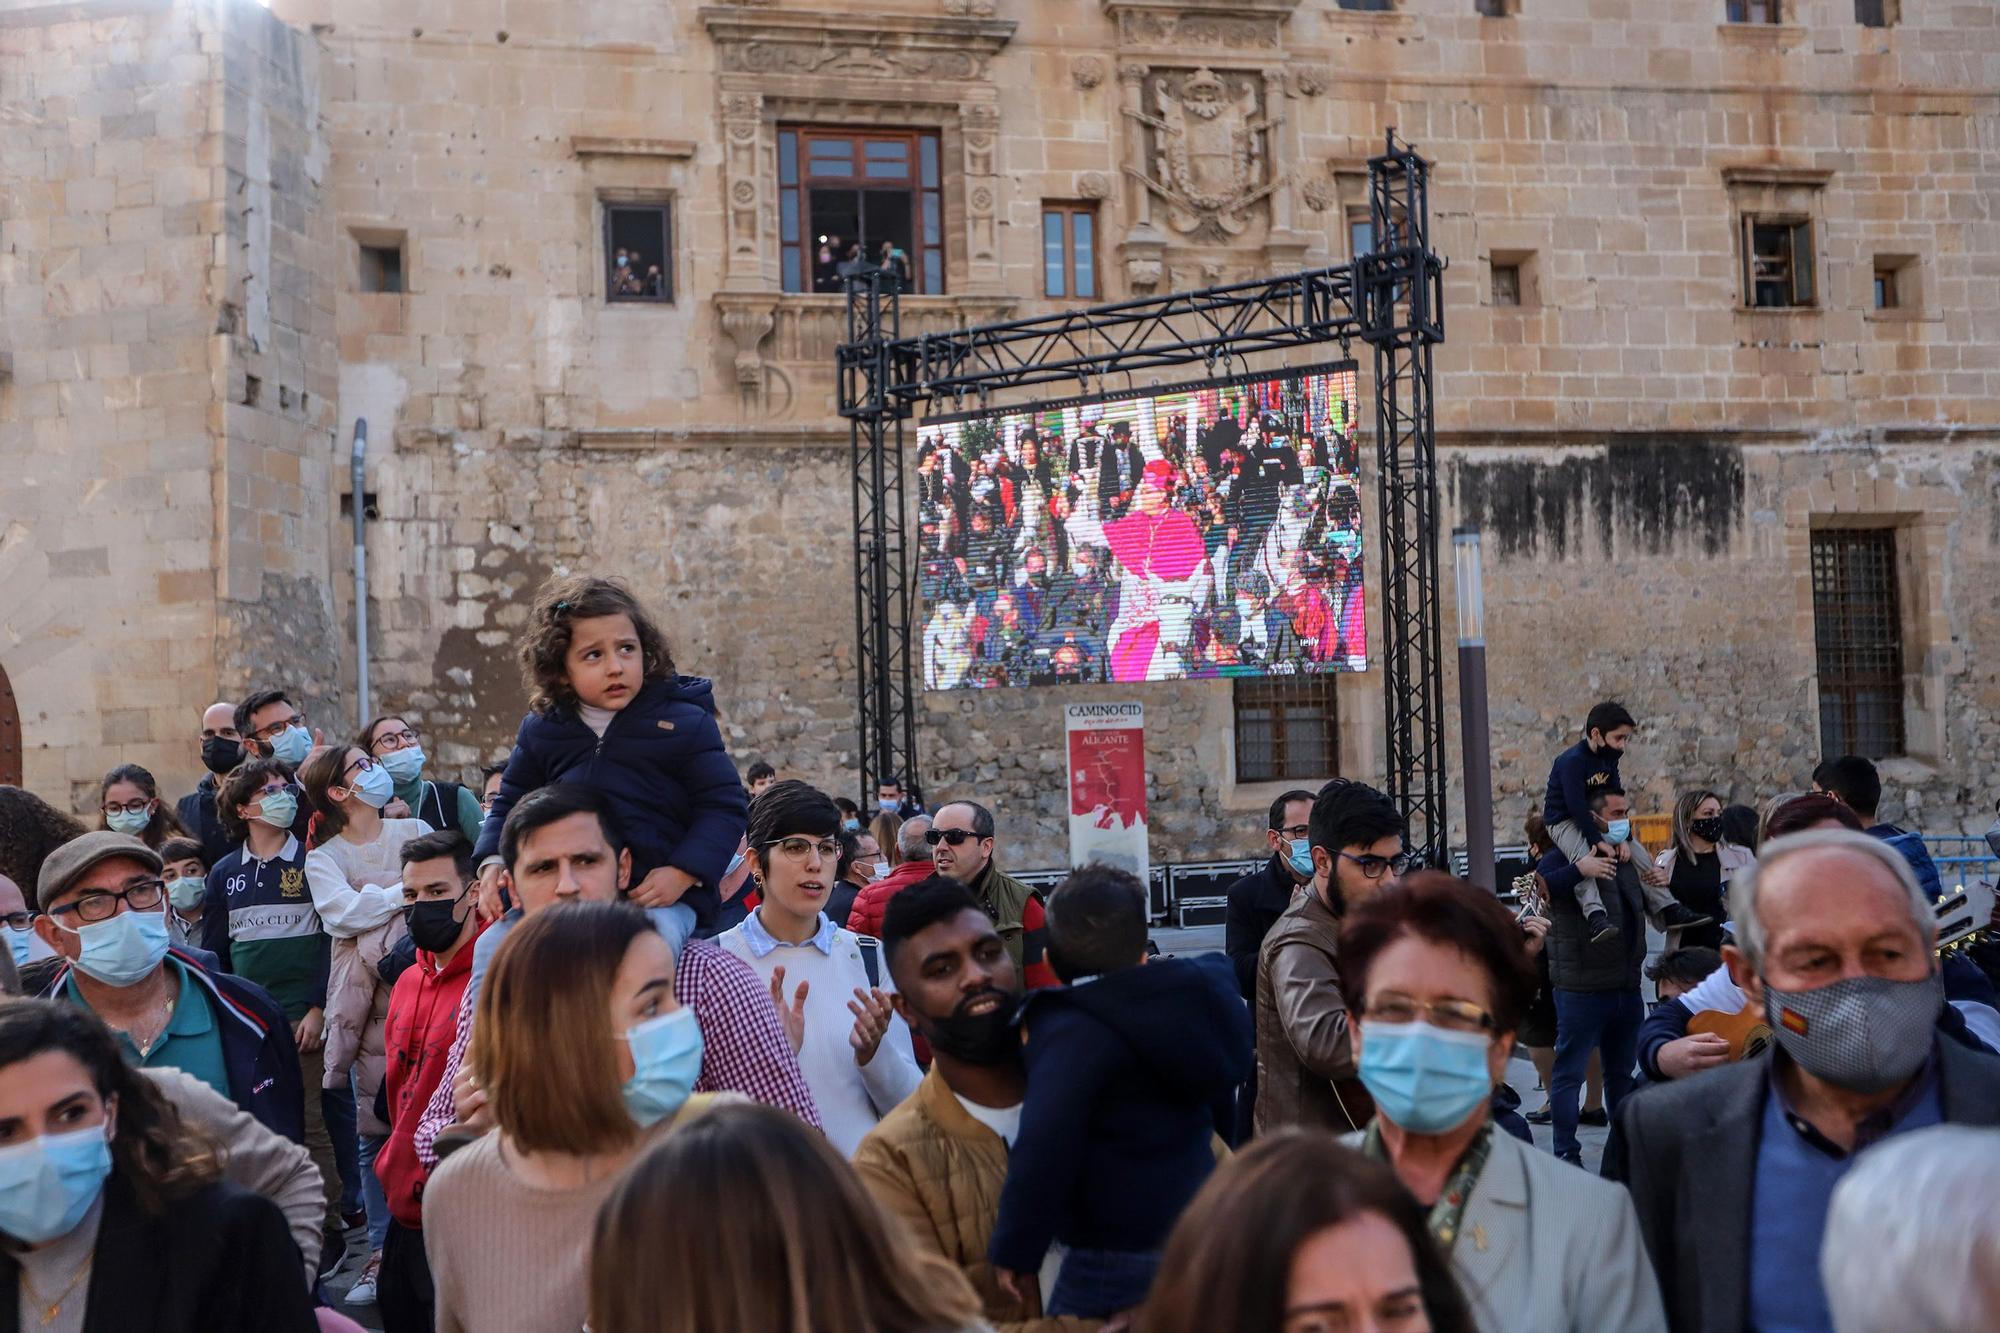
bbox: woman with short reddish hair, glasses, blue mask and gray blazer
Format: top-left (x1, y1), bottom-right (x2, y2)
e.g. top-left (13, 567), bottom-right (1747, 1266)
top-left (1340, 871), bottom-right (1666, 1333)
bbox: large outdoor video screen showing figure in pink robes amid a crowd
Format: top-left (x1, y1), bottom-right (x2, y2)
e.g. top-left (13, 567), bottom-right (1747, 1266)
top-left (916, 362), bottom-right (1368, 691)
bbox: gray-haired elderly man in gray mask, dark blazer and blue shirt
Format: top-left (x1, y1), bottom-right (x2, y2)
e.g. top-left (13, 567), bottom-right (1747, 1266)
top-left (1604, 829), bottom-right (2000, 1333)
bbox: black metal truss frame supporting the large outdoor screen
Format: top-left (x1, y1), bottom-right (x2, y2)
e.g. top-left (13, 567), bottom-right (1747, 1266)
top-left (836, 130), bottom-right (1446, 865)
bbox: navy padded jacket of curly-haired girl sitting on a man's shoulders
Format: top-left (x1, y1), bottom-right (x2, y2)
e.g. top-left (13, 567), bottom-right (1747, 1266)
top-left (474, 677), bottom-right (750, 925)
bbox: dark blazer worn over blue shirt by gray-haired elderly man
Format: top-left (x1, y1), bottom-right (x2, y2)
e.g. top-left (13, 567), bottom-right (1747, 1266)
top-left (1604, 1039), bottom-right (2000, 1333)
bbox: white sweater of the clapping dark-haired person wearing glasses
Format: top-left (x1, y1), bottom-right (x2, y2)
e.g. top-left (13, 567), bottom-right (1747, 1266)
top-left (716, 913), bottom-right (924, 1157)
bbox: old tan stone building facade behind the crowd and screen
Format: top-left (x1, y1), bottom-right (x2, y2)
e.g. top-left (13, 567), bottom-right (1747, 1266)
top-left (0, 0), bottom-right (2000, 865)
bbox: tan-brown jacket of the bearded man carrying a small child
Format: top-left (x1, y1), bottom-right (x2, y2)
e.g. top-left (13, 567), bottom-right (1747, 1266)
top-left (854, 1067), bottom-right (1098, 1333)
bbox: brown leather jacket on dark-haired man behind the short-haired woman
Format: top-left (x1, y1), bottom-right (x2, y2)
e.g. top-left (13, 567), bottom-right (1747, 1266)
top-left (1256, 887), bottom-right (1374, 1133)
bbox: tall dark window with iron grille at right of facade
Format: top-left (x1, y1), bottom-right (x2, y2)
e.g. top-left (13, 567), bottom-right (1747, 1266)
top-left (1812, 528), bottom-right (1904, 759)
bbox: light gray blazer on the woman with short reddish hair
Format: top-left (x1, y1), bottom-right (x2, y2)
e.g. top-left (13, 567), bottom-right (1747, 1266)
top-left (1346, 1127), bottom-right (1666, 1333)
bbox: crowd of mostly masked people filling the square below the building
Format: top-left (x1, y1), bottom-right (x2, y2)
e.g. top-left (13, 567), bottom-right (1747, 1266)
top-left (0, 576), bottom-right (2000, 1333)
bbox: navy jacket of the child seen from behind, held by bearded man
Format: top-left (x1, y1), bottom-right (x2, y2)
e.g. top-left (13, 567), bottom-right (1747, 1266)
top-left (988, 953), bottom-right (1254, 1273)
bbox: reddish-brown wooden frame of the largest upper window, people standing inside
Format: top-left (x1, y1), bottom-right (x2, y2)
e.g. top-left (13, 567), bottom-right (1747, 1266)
top-left (778, 122), bottom-right (950, 296)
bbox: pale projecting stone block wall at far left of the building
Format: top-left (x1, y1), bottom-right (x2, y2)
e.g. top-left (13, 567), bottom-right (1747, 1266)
top-left (0, 0), bottom-right (340, 807)
